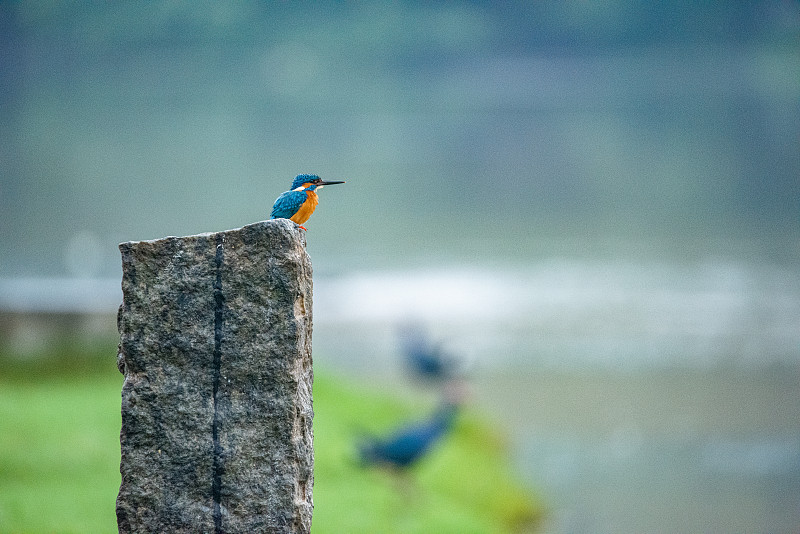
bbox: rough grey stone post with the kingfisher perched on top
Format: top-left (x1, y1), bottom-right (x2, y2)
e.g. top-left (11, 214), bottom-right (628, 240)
top-left (117, 219), bottom-right (313, 533)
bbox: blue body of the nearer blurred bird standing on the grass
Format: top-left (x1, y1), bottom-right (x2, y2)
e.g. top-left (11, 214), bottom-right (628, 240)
top-left (359, 402), bottom-right (459, 469)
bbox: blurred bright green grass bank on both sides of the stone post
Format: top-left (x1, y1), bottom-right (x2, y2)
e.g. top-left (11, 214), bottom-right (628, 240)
top-left (0, 343), bottom-right (543, 534)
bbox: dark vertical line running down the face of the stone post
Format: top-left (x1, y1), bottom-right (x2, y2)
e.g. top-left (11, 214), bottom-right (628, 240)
top-left (211, 234), bottom-right (225, 534)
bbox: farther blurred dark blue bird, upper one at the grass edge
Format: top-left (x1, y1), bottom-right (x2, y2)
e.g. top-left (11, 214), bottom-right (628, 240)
top-left (398, 323), bottom-right (461, 383)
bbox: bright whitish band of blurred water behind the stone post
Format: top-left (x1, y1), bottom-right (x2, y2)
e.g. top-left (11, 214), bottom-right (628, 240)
top-left (0, 258), bottom-right (800, 370)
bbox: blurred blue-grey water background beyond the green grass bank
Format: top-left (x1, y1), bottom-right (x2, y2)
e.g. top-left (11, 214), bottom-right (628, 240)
top-left (0, 0), bottom-right (800, 532)
